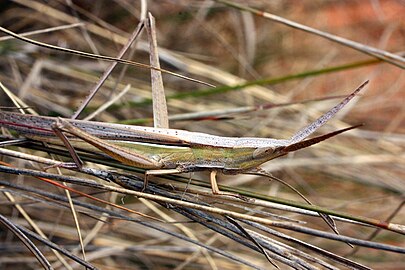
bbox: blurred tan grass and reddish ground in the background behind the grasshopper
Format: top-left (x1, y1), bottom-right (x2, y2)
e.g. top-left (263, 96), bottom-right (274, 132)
top-left (0, 0), bottom-right (405, 269)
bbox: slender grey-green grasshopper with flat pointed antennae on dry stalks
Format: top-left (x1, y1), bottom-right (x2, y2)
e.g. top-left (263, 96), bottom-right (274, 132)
top-left (0, 81), bottom-right (368, 194)
